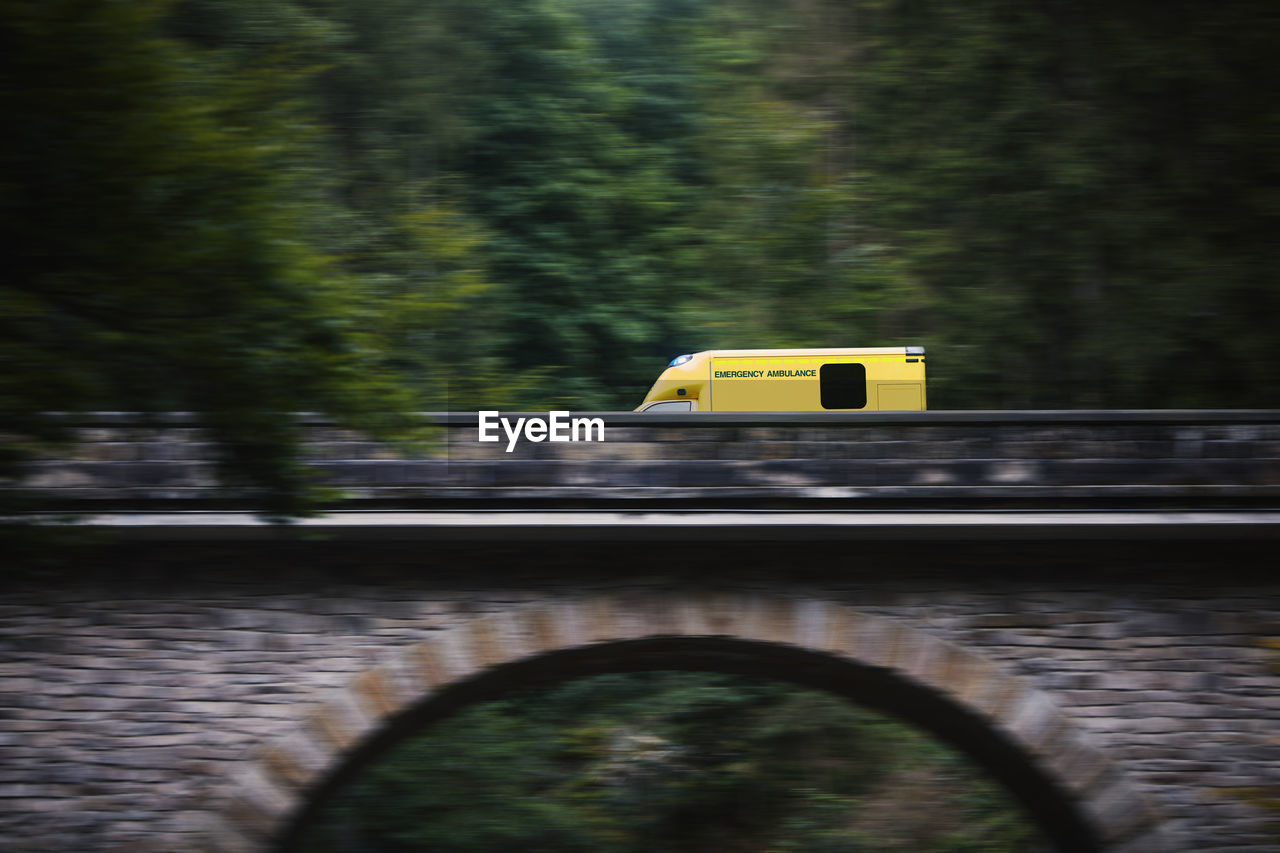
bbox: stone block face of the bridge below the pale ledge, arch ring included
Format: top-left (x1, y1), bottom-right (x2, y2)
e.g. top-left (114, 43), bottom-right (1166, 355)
top-left (0, 540), bottom-right (1280, 853)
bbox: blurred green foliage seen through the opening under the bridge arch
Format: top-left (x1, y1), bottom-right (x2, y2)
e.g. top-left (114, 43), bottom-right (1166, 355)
top-left (300, 672), bottom-right (1036, 853)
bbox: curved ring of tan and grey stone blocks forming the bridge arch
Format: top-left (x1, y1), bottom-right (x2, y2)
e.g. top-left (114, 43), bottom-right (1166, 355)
top-left (206, 592), bottom-right (1184, 853)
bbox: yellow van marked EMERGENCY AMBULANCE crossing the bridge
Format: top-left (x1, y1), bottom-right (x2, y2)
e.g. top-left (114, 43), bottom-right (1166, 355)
top-left (636, 347), bottom-right (924, 412)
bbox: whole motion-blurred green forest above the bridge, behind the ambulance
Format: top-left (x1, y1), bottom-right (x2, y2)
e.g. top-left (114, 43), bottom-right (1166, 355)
top-left (0, 0), bottom-right (1280, 504)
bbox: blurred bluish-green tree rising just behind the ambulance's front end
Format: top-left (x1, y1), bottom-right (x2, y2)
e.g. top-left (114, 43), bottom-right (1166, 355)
top-left (456, 0), bottom-right (706, 409)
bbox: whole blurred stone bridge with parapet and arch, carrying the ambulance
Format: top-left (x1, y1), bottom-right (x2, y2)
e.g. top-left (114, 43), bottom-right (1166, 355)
top-left (0, 412), bottom-right (1280, 853)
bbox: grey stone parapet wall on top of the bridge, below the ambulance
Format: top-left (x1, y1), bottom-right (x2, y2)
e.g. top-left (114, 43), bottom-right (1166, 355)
top-left (17, 411), bottom-right (1280, 507)
